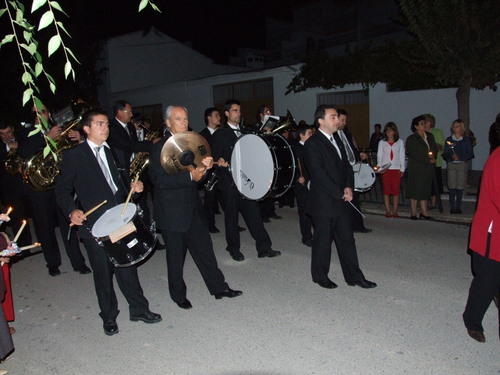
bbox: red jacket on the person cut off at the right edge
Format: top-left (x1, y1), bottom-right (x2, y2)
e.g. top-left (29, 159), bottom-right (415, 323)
top-left (469, 148), bottom-right (500, 262)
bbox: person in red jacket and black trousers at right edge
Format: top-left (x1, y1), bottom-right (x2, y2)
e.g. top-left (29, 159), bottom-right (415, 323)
top-left (463, 148), bottom-right (500, 342)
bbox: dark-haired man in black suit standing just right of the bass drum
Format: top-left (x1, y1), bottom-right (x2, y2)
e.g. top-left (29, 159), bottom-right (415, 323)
top-left (304, 105), bottom-right (377, 289)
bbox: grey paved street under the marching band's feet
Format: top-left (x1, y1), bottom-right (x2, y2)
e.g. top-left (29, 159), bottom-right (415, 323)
top-left (0, 207), bottom-right (500, 375)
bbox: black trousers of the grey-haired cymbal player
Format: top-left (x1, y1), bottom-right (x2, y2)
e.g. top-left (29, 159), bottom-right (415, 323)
top-left (162, 213), bottom-right (229, 302)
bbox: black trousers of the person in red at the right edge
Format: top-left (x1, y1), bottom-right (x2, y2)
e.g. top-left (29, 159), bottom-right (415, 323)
top-left (463, 252), bottom-right (500, 334)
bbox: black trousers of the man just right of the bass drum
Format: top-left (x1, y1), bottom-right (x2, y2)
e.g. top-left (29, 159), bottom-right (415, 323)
top-left (311, 203), bottom-right (365, 283)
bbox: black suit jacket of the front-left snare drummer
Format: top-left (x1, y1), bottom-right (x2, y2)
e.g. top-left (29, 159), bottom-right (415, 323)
top-left (55, 141), bottom-right (129, 227)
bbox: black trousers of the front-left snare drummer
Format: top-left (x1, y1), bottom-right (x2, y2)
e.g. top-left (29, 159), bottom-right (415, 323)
top-left (83, 238), bottom-right (149, 321)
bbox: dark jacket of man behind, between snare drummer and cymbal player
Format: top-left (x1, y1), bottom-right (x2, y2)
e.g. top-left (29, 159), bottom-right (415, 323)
top-left (107, 118), bottom-right (153, 170)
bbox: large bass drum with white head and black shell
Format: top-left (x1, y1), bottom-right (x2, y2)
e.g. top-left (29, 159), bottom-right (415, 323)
top-left (231, 134), bottom-right (295, 200)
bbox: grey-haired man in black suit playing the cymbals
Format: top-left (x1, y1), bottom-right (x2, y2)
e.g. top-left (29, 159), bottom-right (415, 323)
top-left (149, 105), bottom-right (241, 309)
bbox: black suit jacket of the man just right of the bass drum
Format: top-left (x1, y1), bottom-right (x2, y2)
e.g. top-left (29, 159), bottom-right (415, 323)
top-left (304, 131), bottom-right (354, 218)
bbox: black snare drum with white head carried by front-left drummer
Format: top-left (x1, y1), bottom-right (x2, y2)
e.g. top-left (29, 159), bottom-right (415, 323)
top-left (92, 203), bottom-right (157, 267)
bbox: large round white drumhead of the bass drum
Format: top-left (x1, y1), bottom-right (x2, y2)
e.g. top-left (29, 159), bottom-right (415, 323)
top-left (231, 134), bottom-right (274, 200)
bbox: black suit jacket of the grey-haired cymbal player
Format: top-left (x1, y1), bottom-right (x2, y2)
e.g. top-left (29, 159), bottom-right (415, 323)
top-left (149, 133), bottom-right (206, 232)
